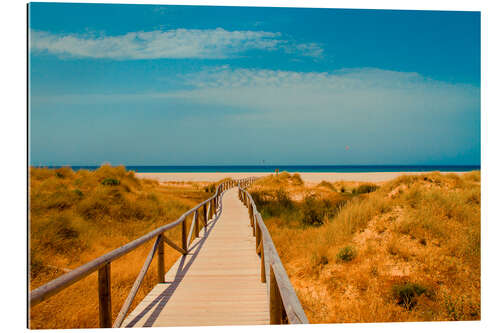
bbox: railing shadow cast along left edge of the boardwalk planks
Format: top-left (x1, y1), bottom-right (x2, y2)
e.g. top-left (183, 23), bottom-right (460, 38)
top-left (125, 200), bottom-right (222, 327)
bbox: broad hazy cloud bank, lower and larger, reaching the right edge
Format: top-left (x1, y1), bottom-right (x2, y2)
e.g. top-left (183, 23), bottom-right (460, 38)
top-left (165, 67), bottom-right (479, 118)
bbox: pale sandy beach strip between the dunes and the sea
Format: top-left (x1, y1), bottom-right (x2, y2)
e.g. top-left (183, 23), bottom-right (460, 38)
top-left (136, 172), bottom-right (464, 183)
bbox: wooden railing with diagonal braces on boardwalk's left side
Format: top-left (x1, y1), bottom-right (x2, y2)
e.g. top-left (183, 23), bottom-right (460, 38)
top-left (29, 179), bottom-right (244, 327)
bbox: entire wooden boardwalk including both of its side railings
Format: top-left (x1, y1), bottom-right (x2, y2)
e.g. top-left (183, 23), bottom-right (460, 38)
top-left (30, 178), bottom-right (308, 327)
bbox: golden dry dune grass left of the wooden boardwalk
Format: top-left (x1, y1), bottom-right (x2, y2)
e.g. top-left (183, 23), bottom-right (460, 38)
top-left (29, 165), bottom-right (212, 329)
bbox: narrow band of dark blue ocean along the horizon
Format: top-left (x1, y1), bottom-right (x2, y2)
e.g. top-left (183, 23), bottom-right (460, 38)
top-left (42, 165), bottom-right (481, 173)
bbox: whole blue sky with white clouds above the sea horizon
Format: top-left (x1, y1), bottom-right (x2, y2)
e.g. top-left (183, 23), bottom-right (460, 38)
top-left (29, 3), bottom-right (481, 165)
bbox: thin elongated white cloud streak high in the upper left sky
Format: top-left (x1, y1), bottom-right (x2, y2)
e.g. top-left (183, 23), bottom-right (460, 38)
top-left (30, 28), bottom-right (323, 60)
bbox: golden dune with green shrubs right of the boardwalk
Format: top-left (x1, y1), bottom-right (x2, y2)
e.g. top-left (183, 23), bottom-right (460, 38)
top-left (250, 171), bottom-right (481, 323)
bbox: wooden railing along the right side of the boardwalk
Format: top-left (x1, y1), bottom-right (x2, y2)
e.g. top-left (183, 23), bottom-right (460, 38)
top-left (238, 183), bottom-right (309, 324)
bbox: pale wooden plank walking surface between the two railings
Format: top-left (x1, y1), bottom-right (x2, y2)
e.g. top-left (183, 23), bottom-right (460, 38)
top-left (121, 188), bottom-right (270, 327)
